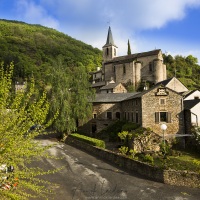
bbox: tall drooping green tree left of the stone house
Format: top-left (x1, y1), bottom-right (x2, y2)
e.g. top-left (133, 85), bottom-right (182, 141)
top-left (48, 56), bottom-right (94, 136)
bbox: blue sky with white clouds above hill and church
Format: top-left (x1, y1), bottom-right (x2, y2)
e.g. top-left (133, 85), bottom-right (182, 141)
top-left (0, 0), bottom-right (200, 63)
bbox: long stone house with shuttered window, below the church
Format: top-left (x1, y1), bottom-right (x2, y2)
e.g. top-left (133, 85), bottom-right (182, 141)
top-left (80, 85), bottom-right (184, 135)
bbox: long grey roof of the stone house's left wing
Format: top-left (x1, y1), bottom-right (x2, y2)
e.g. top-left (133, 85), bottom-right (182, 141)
top-left (92, 92), bottom-right (137, 103)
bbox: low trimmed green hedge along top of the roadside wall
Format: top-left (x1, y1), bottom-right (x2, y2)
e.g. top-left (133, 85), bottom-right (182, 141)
top-left (70, 133), bottom-right (106, 148)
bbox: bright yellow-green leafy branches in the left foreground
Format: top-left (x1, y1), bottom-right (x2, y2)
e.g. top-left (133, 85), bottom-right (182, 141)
top-left (0, 63), bottom-right (57, 200)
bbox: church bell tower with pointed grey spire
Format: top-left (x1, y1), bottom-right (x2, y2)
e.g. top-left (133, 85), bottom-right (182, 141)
top-left (102, 26), bottom-right (118, 62)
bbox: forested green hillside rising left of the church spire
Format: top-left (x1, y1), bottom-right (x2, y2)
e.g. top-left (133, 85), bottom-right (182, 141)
top-left (0, 20), bottom-right (102, 80)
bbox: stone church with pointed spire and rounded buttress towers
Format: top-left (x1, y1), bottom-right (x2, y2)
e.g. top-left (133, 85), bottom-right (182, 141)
top-left (92, 27), bottom-right (167, 92)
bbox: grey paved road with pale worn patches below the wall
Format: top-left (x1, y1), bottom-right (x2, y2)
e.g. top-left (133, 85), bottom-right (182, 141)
top-left (33, 139), bottom-right (200, 200)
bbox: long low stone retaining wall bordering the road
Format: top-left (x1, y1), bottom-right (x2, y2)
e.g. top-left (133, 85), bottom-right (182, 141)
top-left (66, 136), bottom-right (200, 188)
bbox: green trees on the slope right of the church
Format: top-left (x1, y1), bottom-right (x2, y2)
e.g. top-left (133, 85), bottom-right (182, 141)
top-left (163, 54), bottom-right (200, 90)
